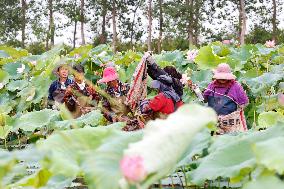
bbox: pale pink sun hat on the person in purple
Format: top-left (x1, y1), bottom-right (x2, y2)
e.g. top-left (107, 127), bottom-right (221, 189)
top-left (213, 63), bottom-right (236, 80)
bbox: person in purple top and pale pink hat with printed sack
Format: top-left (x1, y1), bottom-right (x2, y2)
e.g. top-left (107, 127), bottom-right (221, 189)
top-left (203, 63), bottom-right (248, 134)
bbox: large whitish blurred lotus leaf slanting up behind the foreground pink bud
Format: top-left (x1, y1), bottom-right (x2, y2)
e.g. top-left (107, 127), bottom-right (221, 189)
top-left (124, 104), bottom-right (216, 189)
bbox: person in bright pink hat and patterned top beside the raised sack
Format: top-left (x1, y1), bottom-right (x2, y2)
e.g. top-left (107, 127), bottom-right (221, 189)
top-left (98, 67), bottom-right (130, 122)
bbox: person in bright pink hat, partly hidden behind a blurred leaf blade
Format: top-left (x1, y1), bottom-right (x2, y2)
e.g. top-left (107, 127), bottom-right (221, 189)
top-left (98, 67), bottom-right (130, 122)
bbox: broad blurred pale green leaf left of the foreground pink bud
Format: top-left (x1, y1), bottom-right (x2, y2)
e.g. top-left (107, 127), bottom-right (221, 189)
top-left (37, 127), bottom-right (141, 184)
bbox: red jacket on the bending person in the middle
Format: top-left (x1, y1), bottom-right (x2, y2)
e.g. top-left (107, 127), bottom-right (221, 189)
top-left (149, 93), bottom-right (183, 114)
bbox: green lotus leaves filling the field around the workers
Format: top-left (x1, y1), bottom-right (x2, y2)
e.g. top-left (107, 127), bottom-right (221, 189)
top-left (0, 42), bottom-right (284, 189)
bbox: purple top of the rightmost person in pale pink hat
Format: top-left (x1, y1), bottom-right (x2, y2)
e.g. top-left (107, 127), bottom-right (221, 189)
top-left (203, 81), bottom-right (248, 105)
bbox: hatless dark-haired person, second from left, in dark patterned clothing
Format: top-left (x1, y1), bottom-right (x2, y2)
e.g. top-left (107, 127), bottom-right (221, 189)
top-left (64, 64), bottom-right (99, 118)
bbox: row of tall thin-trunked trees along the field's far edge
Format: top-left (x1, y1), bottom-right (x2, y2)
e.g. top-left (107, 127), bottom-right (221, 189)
top-left (0, 0), bottom-right (284, 54)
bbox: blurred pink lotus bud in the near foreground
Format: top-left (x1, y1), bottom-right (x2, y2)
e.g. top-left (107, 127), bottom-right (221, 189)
top-left (120, 156), bottom-right (147, 183)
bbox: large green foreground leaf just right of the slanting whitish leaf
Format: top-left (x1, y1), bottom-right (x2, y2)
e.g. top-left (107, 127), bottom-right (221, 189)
top-left (189, 126), bottom-right (284, 185)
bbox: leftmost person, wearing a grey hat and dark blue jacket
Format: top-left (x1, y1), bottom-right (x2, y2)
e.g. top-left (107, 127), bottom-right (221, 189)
top-left (48, 64), bottom-right (73, 104)
